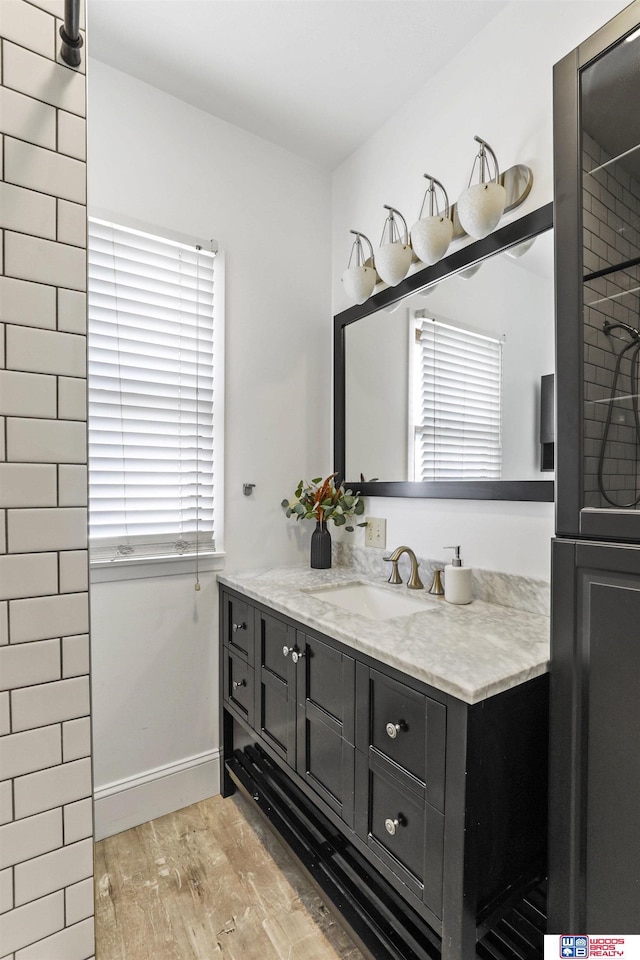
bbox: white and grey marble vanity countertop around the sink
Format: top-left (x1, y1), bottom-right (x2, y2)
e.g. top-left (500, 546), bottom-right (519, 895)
top-left (218, 567), bottom-right (549, 703)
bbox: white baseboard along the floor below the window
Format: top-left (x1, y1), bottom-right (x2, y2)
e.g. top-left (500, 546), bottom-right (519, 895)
top-left (93, 750), bottom-right (220, 840)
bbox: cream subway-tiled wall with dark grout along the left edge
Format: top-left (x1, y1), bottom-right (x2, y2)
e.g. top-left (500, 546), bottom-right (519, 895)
top-left (0, 0), bottom-right (94, 960)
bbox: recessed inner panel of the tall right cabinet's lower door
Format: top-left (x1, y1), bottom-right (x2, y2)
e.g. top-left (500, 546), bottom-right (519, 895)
top-left (580, 575), bottom-right (640, 934)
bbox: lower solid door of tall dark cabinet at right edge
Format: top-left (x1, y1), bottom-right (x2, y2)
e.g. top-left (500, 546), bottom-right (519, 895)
top-left (549, 541), bottom-right (640, 934)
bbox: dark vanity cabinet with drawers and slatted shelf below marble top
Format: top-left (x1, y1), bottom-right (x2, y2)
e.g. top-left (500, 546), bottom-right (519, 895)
top-left (220, 586), bottom-right (548, 960)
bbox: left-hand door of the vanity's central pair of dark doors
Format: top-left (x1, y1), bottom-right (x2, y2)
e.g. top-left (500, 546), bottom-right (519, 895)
top-left (255, 610), bottom-right (297, 767)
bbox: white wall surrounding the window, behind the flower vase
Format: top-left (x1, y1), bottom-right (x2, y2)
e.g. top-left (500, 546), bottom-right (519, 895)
top-left (88, 62), bottom-right (331, 836)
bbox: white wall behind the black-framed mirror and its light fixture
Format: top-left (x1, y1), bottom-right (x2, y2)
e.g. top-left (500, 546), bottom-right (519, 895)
top-left (333, 0), bottom-right (626, 579)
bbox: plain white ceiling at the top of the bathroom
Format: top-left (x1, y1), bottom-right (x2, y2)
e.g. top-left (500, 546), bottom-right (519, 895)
top-left (87, 0), bottom-right (508, 168)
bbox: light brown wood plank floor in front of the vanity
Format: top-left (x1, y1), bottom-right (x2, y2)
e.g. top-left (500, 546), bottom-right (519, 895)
top-left (95, 795), bottom-right (363, 960)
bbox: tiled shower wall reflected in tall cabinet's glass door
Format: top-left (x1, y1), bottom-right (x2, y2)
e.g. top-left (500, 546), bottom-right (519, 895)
top-left (583, 136), bottom-right (640, 507)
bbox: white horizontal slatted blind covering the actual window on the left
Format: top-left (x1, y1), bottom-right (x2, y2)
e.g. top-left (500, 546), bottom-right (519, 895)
top-left (88, 218), bottom-right (215, 560)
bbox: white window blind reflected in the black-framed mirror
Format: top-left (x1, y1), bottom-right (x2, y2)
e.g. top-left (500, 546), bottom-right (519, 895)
top-left (413, 317), bottom-right (502, 480)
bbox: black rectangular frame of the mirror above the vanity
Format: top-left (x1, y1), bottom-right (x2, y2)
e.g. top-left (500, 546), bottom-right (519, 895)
top-left (333, 203), bottom-right (555, 503)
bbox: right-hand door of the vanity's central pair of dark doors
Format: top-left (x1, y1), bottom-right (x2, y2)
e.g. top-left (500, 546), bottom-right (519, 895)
top-left (296, 633), bottom-right (355, 825)
